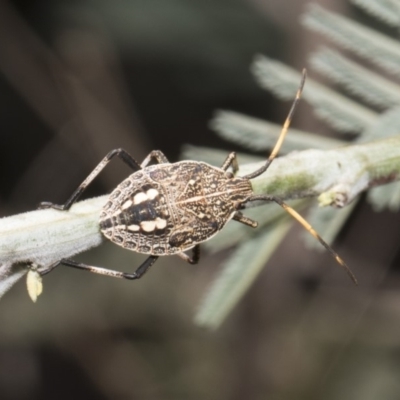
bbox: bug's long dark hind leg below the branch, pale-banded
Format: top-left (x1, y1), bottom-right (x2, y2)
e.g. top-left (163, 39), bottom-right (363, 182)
top-left (39, 256), bottom-right (158, 279)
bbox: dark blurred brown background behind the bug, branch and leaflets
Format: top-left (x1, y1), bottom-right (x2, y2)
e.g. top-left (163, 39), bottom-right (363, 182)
top-left (0, 0), bottom-right (400, 400)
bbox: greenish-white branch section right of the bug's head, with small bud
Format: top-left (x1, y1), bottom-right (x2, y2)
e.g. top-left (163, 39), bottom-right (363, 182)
top-left (248, 136), bottom-right (400, 207)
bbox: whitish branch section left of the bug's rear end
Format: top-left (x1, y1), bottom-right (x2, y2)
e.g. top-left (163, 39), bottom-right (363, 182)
top-left (0, 196), bottom-right (106, 297)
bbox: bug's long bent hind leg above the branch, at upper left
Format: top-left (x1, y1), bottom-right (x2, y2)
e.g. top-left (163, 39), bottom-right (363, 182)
top-left (39, 149), bottom-right (142, 210)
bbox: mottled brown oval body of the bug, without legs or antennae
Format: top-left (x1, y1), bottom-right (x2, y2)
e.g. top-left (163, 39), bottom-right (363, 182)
top-left (100, 161), bottom-right (252, 256)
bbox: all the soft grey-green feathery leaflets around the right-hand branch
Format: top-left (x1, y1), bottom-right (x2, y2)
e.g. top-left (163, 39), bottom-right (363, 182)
top-left (191, 0), bottom-right (400, 328)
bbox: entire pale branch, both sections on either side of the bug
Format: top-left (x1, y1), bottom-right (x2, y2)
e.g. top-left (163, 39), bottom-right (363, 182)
top-left (0, 136), bottom-right (400, 296)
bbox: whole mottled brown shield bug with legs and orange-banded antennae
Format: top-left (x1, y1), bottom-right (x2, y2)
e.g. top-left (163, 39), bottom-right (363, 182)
top-left (40, 70), bottom-right (357, 283)
